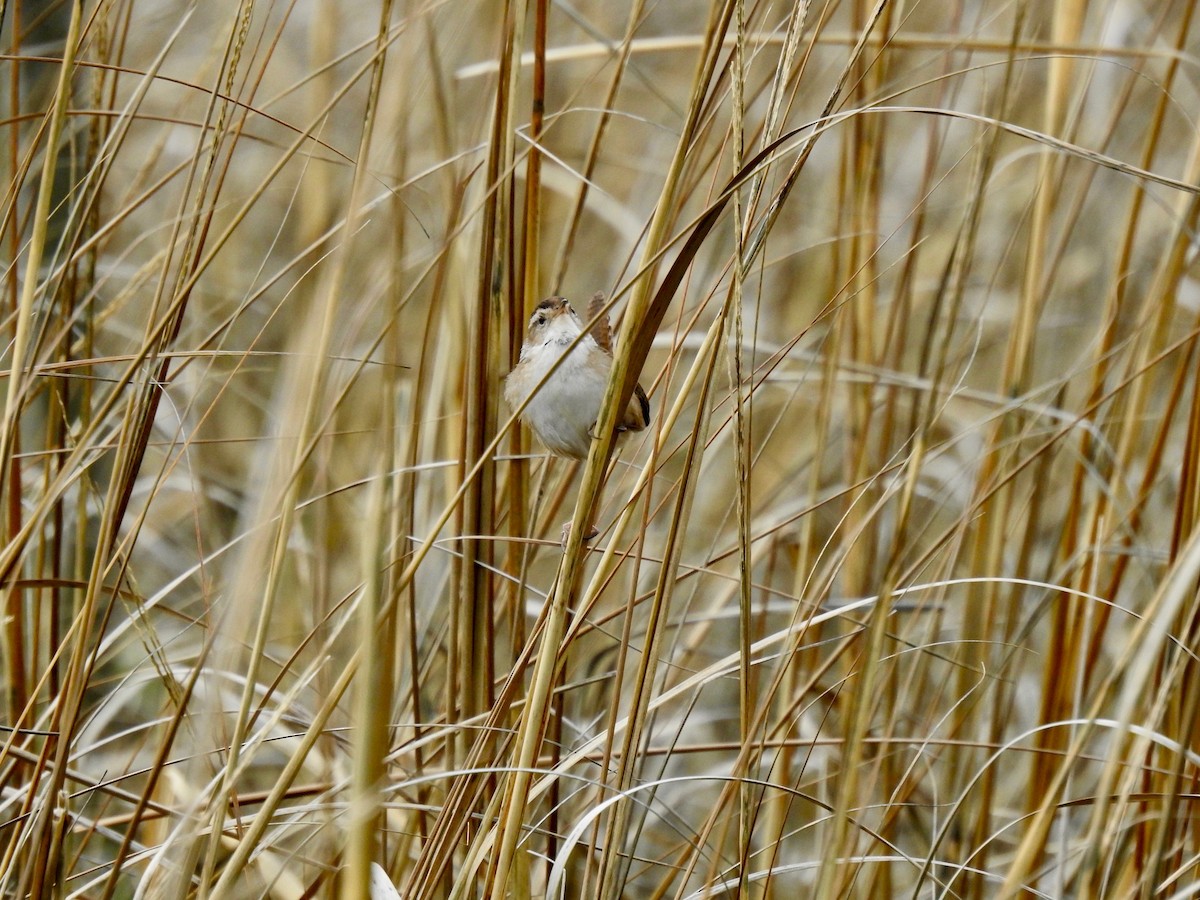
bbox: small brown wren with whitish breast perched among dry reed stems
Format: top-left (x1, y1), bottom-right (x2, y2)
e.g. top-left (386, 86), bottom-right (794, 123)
top-left (504, 293), bottom-right (650, 460)
